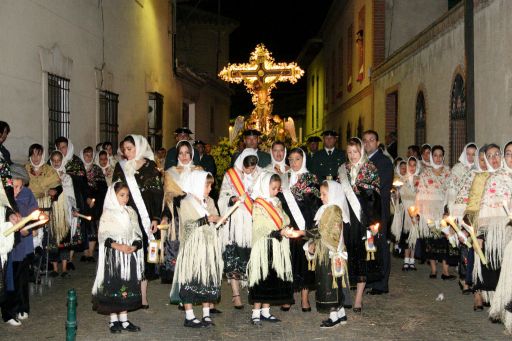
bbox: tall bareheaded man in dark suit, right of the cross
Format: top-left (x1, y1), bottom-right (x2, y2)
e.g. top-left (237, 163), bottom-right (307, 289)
top-left (363, 130), bottom-right (393, 295)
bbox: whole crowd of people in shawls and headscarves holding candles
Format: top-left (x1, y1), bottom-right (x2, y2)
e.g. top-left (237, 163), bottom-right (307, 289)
top-left (0, 121), bottom-right (512, 333)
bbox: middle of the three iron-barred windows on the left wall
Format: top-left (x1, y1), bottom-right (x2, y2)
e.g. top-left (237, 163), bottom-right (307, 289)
top-left (100, 91), bottom-right (119, 146)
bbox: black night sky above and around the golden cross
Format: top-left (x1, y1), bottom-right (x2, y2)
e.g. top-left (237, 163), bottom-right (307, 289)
top-left (187, 0), bottom-right (332, 117)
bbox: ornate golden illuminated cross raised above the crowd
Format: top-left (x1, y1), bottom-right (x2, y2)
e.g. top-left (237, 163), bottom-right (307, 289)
top-left (219, 44), bottom-right (304, 107)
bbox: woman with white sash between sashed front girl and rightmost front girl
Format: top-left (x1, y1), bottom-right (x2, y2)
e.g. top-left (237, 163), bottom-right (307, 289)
top-left (279, 148), bottom-right (321, 312)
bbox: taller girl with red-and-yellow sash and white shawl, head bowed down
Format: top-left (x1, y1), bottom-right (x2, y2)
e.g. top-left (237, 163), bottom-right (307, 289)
top-left (218, 148), bottom-right (261, 309)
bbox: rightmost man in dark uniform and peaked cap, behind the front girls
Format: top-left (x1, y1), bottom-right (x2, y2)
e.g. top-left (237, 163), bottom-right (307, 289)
top-left (307, 130), bottom-right (346, 182)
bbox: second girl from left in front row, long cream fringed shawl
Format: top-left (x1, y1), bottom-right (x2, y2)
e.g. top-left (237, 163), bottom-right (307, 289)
top-left (171, 170), bottom-right (223, 328)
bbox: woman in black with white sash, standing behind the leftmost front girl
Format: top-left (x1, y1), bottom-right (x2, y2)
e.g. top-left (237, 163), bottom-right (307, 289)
top-left (112, 135), bottom-right (164, 309)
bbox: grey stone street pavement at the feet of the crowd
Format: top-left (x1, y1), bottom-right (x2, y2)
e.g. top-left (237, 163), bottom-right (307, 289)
top-left (0, 255), bottom-right (511, 341)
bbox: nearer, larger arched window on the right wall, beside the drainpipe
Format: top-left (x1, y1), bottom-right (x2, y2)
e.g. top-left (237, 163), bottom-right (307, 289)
top-left (450, 73), bottom-right (467, 165)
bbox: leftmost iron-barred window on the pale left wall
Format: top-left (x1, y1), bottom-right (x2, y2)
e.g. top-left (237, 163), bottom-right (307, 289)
top-left (48, 73), bottom-right (69, 150)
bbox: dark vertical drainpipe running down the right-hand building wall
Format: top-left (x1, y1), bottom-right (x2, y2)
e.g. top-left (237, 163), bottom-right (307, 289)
top-left (464, 0), bottom-right (475, 142)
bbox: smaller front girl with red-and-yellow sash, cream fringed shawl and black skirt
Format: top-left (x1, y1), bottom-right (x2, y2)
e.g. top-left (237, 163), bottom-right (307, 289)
top-left (247, 172), bottom-right (294, 325)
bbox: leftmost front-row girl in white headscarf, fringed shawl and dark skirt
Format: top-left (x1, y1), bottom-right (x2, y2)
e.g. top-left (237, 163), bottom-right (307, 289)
top-left (92, 182), bottom-right (144, 333)
